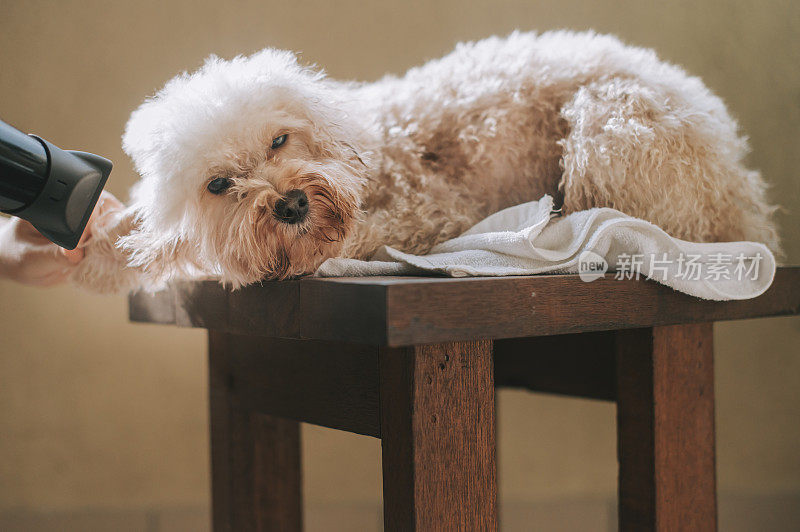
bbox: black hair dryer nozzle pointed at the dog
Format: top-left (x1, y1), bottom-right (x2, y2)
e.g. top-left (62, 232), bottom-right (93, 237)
top-left (0, 121), bottom-right (112, 249)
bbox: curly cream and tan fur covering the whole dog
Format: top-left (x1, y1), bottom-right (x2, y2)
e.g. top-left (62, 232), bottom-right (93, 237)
top-left (70, 31), bottom-right (779, 291)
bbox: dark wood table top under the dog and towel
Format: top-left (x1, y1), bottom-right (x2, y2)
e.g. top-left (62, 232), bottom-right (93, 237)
top-left (129, 266), bottom-right (800, 346)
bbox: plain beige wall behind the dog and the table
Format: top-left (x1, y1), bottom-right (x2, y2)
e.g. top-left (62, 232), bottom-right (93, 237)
top-left (0, 0), bottom-right (800, 522)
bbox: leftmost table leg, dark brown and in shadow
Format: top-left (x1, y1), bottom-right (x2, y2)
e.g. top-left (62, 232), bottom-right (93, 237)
top-left (209, 331), bottom-right (303, 532)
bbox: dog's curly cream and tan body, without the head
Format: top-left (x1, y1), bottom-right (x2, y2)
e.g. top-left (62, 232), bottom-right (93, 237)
top-left (345, 32), bottom-right (779, 258)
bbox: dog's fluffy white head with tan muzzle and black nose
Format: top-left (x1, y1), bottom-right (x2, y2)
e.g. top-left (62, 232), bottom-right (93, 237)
top-left (120, 49), bottom-right (368, 286)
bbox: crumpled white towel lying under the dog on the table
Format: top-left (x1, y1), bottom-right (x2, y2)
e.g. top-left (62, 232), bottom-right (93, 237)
top-left (315, 196), bottom-right (775, 301)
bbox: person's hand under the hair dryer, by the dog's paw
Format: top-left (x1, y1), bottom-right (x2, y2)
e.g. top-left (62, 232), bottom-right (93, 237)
top-left (0, 191), bottom-right (123, 286)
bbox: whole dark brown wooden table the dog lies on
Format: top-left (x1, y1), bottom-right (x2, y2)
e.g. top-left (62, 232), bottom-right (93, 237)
top-left (130, 267), bottom-right (800, 532)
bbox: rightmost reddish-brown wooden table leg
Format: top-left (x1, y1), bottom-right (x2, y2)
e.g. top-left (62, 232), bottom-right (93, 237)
top-left (616, 323), bottom-right (717, 531)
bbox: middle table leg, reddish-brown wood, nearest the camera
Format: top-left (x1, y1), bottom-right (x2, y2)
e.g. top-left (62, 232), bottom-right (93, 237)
top-left (380, 341), bottom-right (497, 531)
